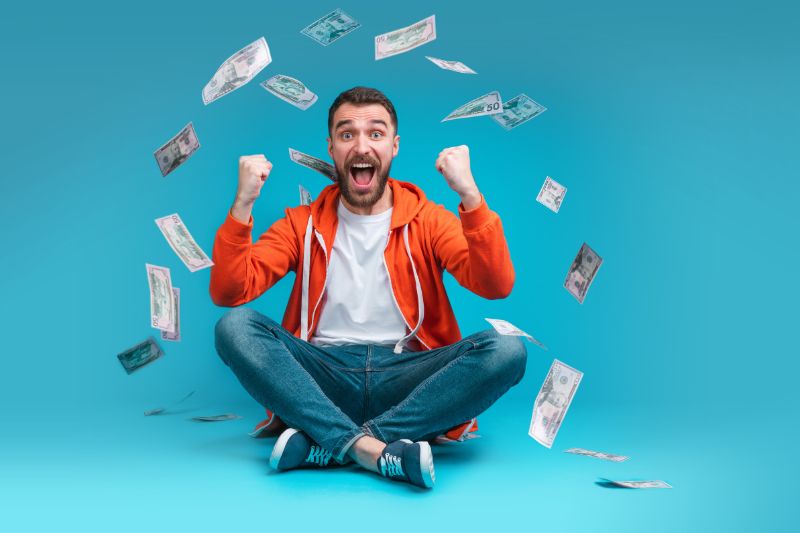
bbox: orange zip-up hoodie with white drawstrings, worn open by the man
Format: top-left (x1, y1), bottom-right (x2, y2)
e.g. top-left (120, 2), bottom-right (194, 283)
top-left (210, 178), bottom-right (514, 435)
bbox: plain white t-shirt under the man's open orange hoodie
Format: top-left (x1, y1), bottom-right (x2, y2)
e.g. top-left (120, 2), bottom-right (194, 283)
top-left (311, 201), bottom-right (406, 346)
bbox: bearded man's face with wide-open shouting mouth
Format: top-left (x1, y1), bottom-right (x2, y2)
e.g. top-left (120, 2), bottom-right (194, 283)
top-left (328, 103), bottom-right (400, 207)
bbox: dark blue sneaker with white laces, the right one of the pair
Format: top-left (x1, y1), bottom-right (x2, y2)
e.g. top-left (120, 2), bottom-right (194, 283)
top-left (378, 439), bottom-right (436, 489)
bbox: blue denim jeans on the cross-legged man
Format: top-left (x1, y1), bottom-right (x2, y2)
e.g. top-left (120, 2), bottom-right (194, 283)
top-left (216, 307), bottom-right (527, 461)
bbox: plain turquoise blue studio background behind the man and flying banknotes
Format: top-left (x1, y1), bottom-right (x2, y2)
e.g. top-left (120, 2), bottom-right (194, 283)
top-left (0, 0), bottom-right (800, 531)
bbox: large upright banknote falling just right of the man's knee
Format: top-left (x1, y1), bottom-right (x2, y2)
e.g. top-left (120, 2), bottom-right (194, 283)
top-left (528, 359), bottom-right (583, 448)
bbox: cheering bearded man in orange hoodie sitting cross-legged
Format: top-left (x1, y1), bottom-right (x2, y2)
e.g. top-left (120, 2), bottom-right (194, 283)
top-left (210, 87), bottom-right (527, 488)
